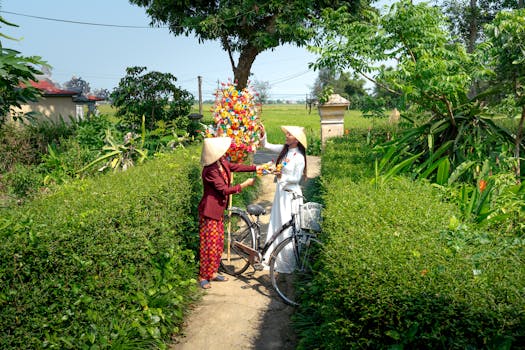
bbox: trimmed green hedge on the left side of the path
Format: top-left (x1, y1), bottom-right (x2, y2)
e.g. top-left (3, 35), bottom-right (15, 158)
top-left (0, 149), bottom-right (201, 349)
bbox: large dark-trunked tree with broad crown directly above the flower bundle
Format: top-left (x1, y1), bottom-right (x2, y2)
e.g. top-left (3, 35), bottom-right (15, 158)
top-left (130, 0), bottom-right (371, 89)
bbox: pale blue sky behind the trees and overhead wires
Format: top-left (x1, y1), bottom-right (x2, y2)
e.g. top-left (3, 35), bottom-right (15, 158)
top-left (0, 0), bottom-right (324, 99)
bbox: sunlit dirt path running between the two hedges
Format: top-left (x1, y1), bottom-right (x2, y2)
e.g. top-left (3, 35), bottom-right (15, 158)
top-left (170, 152), bottom-right (320, 350)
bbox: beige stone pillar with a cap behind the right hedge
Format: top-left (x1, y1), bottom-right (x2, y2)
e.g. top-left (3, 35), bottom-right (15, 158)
top-left (318, 94), bottom-right (350, 147)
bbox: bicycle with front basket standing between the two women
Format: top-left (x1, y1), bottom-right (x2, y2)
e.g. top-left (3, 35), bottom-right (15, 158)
top-left (221, 191), bottom-right (322, 305)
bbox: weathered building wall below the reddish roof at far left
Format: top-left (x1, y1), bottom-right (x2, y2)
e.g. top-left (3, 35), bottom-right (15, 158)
top-left (11, 96), bottom-right (82, 122)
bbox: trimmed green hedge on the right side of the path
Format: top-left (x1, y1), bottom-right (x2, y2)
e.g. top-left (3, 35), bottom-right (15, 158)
top-left (294, 135), bottom-right (525, 349)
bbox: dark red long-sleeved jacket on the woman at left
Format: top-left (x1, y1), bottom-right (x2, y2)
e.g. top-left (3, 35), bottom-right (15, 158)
top-left (199, 157), bottom-right (256, 220)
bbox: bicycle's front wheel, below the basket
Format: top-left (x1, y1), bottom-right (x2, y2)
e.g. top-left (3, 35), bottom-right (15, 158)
top-left (270, 234), bottom-right (322, 305)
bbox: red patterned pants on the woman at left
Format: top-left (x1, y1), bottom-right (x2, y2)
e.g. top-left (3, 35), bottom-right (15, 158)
top-left (199, 217), bottom-right (224, 281)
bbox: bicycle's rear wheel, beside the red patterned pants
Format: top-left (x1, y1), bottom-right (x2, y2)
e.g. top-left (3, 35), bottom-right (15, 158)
top-left (221, 211), bottom-right (254, 275)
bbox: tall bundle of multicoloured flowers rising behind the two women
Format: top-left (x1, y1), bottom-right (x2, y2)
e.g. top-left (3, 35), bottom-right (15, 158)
top-left (204, 81), bottom-right (260, 163)
